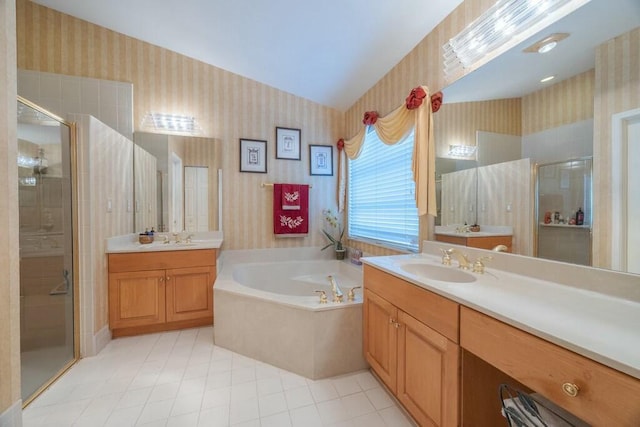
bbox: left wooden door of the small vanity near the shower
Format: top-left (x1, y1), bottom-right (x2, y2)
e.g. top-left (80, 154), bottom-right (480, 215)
top-left (109, 270), bottom-right (165, 329)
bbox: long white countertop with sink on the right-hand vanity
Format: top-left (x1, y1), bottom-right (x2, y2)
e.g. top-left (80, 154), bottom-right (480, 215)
top-left (362, 242), bottom-right (640, 379)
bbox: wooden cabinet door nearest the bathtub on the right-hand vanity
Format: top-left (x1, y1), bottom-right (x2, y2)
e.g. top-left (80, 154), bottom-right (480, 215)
top-left (362, 289), bottom-right (398, 393)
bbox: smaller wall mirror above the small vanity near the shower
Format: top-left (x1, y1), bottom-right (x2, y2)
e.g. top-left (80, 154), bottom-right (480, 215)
top-left (133, 132), bottom-right (222, 232)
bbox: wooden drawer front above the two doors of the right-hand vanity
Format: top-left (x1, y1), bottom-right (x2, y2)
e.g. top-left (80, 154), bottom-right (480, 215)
top-left (364, 265), bottom-right (459, 343)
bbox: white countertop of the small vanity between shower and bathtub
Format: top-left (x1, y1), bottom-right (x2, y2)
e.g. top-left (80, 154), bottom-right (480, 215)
top-left (106, 231), bottom-right (224, 254)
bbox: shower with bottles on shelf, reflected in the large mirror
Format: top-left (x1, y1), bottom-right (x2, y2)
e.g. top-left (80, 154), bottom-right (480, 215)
top-left (536, 158), bottom-right (593, 265)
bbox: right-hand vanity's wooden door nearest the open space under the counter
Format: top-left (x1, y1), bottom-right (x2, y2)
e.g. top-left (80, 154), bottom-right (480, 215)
top-left (396, 311), bottom-right (460, 426)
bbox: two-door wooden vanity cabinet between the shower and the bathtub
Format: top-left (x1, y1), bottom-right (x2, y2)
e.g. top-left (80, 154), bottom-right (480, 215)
top-left (109, 249), bottom-right (216, 337)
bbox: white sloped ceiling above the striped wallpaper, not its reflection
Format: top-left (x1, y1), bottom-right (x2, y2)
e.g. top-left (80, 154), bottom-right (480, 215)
top-left (35, 0), bottom-right (462, 111)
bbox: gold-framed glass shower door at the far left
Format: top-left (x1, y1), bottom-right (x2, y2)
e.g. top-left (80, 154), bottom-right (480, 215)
top-left (17, 98), bottom-right (78, 406)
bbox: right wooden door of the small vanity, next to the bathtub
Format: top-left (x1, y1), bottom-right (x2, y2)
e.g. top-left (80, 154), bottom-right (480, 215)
top-left (167, 266), bottom-right (215, 322)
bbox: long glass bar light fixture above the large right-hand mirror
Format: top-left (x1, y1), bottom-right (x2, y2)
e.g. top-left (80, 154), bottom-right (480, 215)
top-left (443, 0), bottom-right (590, 83)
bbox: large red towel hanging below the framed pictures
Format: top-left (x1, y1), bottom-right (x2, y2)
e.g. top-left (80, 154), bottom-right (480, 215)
top-left (273, 184), bottom-right (309, 237)
